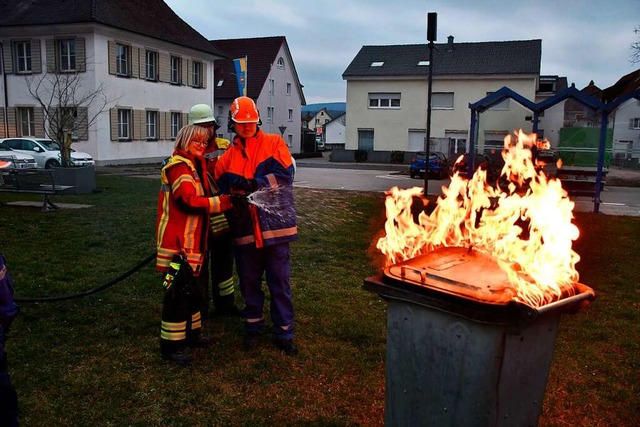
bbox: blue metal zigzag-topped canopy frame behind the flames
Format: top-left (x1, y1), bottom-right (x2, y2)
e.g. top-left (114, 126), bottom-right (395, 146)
top-left (468, 84), bottom-right (640, 213)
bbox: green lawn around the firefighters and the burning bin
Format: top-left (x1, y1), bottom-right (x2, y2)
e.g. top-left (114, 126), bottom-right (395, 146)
top-left (0, 175), bottom-right (640, 426)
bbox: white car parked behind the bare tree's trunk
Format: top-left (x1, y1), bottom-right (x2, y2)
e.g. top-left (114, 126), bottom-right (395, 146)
top-left (0, 137), bottom-right (95, 169)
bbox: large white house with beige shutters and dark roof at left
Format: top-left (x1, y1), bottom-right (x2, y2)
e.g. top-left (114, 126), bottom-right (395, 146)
top-left (0, 0), bottom-right (225, 164)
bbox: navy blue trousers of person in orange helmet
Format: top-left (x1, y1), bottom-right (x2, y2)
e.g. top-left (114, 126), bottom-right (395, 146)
top-left (235, 243), bottom-right (294, 339)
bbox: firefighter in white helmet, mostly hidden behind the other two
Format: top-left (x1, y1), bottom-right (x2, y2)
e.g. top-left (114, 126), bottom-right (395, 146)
top-left (189, 104), bottom-right (240, 317)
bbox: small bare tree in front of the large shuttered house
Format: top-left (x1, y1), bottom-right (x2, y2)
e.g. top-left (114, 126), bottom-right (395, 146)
top-left (25, 67), bottom-right (116, 167)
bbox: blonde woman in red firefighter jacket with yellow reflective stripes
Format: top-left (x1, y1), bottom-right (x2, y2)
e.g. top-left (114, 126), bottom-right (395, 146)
top-left (156, 125), bottom-right (232, 365)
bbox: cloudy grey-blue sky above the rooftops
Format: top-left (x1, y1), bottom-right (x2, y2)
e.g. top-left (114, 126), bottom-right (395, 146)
top-left (165, 0), bottom-right (640, 104)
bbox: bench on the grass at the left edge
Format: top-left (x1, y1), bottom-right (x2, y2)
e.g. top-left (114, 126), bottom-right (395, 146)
top-left (0, 169), bottom-right (74, 212)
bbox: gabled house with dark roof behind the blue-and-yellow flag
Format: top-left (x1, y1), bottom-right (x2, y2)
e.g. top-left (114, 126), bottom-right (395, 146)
top-left (210, 36), bottom-right (306, 153)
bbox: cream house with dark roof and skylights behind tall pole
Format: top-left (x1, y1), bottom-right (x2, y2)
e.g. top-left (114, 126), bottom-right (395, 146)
top-left (334, 36), bottom-right (542, 161)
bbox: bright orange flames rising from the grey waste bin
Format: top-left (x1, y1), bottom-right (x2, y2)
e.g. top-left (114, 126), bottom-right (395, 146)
top-left (376, 130), bottom-right (580, 307)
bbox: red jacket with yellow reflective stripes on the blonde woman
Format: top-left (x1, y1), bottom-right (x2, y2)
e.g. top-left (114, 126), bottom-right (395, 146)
top-left (156, 150), bottom-right (231, 276)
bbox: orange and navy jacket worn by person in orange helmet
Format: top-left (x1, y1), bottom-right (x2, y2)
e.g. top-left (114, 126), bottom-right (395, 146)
top-left (215, 130), bottom-right (298, 247)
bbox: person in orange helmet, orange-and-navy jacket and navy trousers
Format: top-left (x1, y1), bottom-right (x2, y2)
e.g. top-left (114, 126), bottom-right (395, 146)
top-left (215, 96), bottom-right (298, 355)
